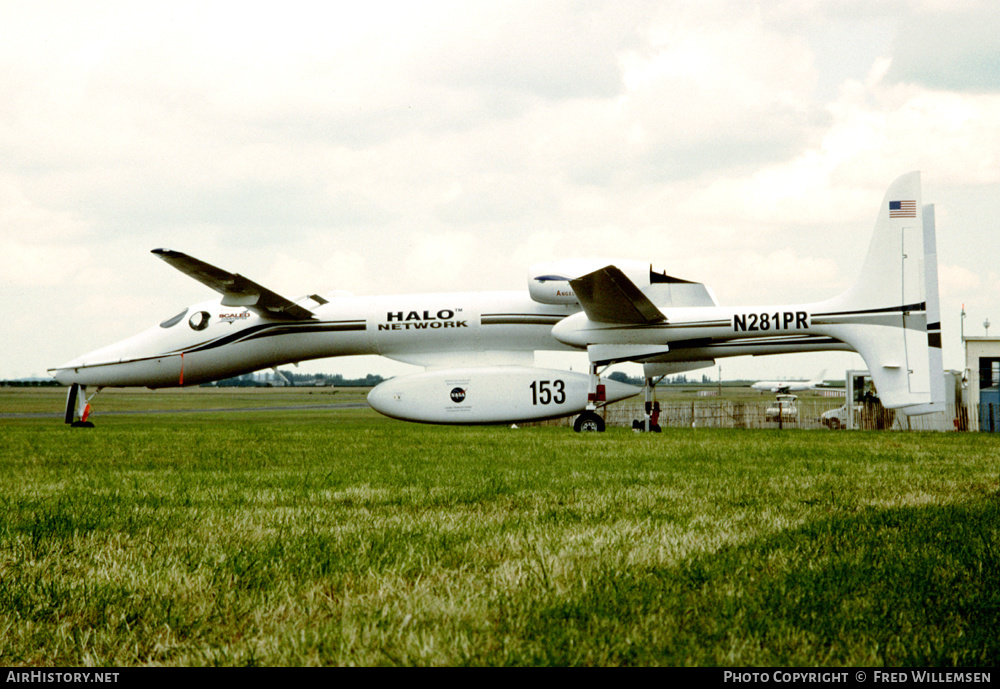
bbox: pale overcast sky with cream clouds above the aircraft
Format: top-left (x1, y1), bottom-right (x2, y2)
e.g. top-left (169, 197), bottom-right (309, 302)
top-left (0, 0), bottom-right (1000, 378)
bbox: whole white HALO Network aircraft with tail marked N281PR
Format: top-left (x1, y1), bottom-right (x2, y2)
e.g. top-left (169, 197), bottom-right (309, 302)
top-left (50, 173), bottom-right (944, 431)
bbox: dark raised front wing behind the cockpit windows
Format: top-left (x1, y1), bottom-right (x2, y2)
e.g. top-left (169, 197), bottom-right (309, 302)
top-left (153, 249), bottom-right (316, 321)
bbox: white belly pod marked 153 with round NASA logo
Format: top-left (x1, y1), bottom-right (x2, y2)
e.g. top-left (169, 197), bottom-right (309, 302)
top-left (368, 366), bottom-right (641, 424)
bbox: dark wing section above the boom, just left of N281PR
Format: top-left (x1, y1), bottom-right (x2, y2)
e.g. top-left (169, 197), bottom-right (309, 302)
top-left (569, 266), bottom-right (667, 325)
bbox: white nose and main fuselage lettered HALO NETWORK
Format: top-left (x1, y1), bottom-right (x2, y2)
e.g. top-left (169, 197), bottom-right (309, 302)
top-left (52, 292), bottom-right (577, 388)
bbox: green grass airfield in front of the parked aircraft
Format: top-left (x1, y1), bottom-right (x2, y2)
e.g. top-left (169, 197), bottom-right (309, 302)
top-left (0, 390), bottom-right (1000, 666)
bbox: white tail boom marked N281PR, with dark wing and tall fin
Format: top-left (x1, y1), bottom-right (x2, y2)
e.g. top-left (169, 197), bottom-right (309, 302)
top-left (552, 172), bottom-right (944, 426)
